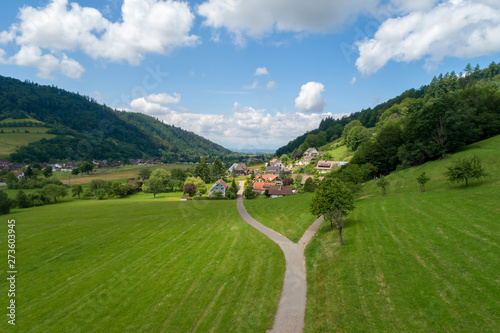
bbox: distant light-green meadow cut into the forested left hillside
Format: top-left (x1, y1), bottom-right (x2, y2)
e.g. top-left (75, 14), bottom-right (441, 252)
top-left (0, 127), bottom-right (56, 158)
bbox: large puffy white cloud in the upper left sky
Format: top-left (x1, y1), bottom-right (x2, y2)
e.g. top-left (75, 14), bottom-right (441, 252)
top-left (0, 0), bottom-right (198, 78)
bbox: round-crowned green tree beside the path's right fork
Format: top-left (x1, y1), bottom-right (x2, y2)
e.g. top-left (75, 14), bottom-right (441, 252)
top-left (309, 178), bottom-right (354, 245)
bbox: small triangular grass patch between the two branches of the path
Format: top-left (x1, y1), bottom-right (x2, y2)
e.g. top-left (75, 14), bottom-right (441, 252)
top-left (245, 193), bottom-right (316, 243)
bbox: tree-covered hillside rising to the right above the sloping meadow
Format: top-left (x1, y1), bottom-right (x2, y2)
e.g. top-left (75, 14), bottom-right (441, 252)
top-left (276, 62), bottom-right (500, 172)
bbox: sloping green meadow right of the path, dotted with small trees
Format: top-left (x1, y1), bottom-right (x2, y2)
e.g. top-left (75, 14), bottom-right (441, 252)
top-left (304, 137), bottom-right (500, 332)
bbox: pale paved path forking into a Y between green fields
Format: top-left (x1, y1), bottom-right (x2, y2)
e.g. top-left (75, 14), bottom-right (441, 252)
top-left (237, 182), bottom-right (323, 333)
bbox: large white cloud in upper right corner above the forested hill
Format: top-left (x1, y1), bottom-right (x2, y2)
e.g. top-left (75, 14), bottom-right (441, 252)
top-left (356, 0), bottom-right (500, 74)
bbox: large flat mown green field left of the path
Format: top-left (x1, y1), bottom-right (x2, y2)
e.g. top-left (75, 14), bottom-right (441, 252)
top-left (0, 197), bottom-right (285, 332)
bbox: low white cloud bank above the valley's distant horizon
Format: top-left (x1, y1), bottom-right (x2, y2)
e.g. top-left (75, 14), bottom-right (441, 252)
top-left (128, 98), bottom-right (345, 148)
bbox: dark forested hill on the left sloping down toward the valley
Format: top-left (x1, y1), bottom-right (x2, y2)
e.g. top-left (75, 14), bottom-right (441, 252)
top-left (0, 76), bottom-right (230, 163)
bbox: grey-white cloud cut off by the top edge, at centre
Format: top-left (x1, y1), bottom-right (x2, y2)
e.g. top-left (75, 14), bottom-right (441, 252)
top-left (198, 0), bottom-right (378, 45)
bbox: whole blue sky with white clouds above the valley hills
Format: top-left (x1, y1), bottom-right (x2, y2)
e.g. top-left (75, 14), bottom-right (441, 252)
top-left (0, 0), bottom-right (500, 149)
